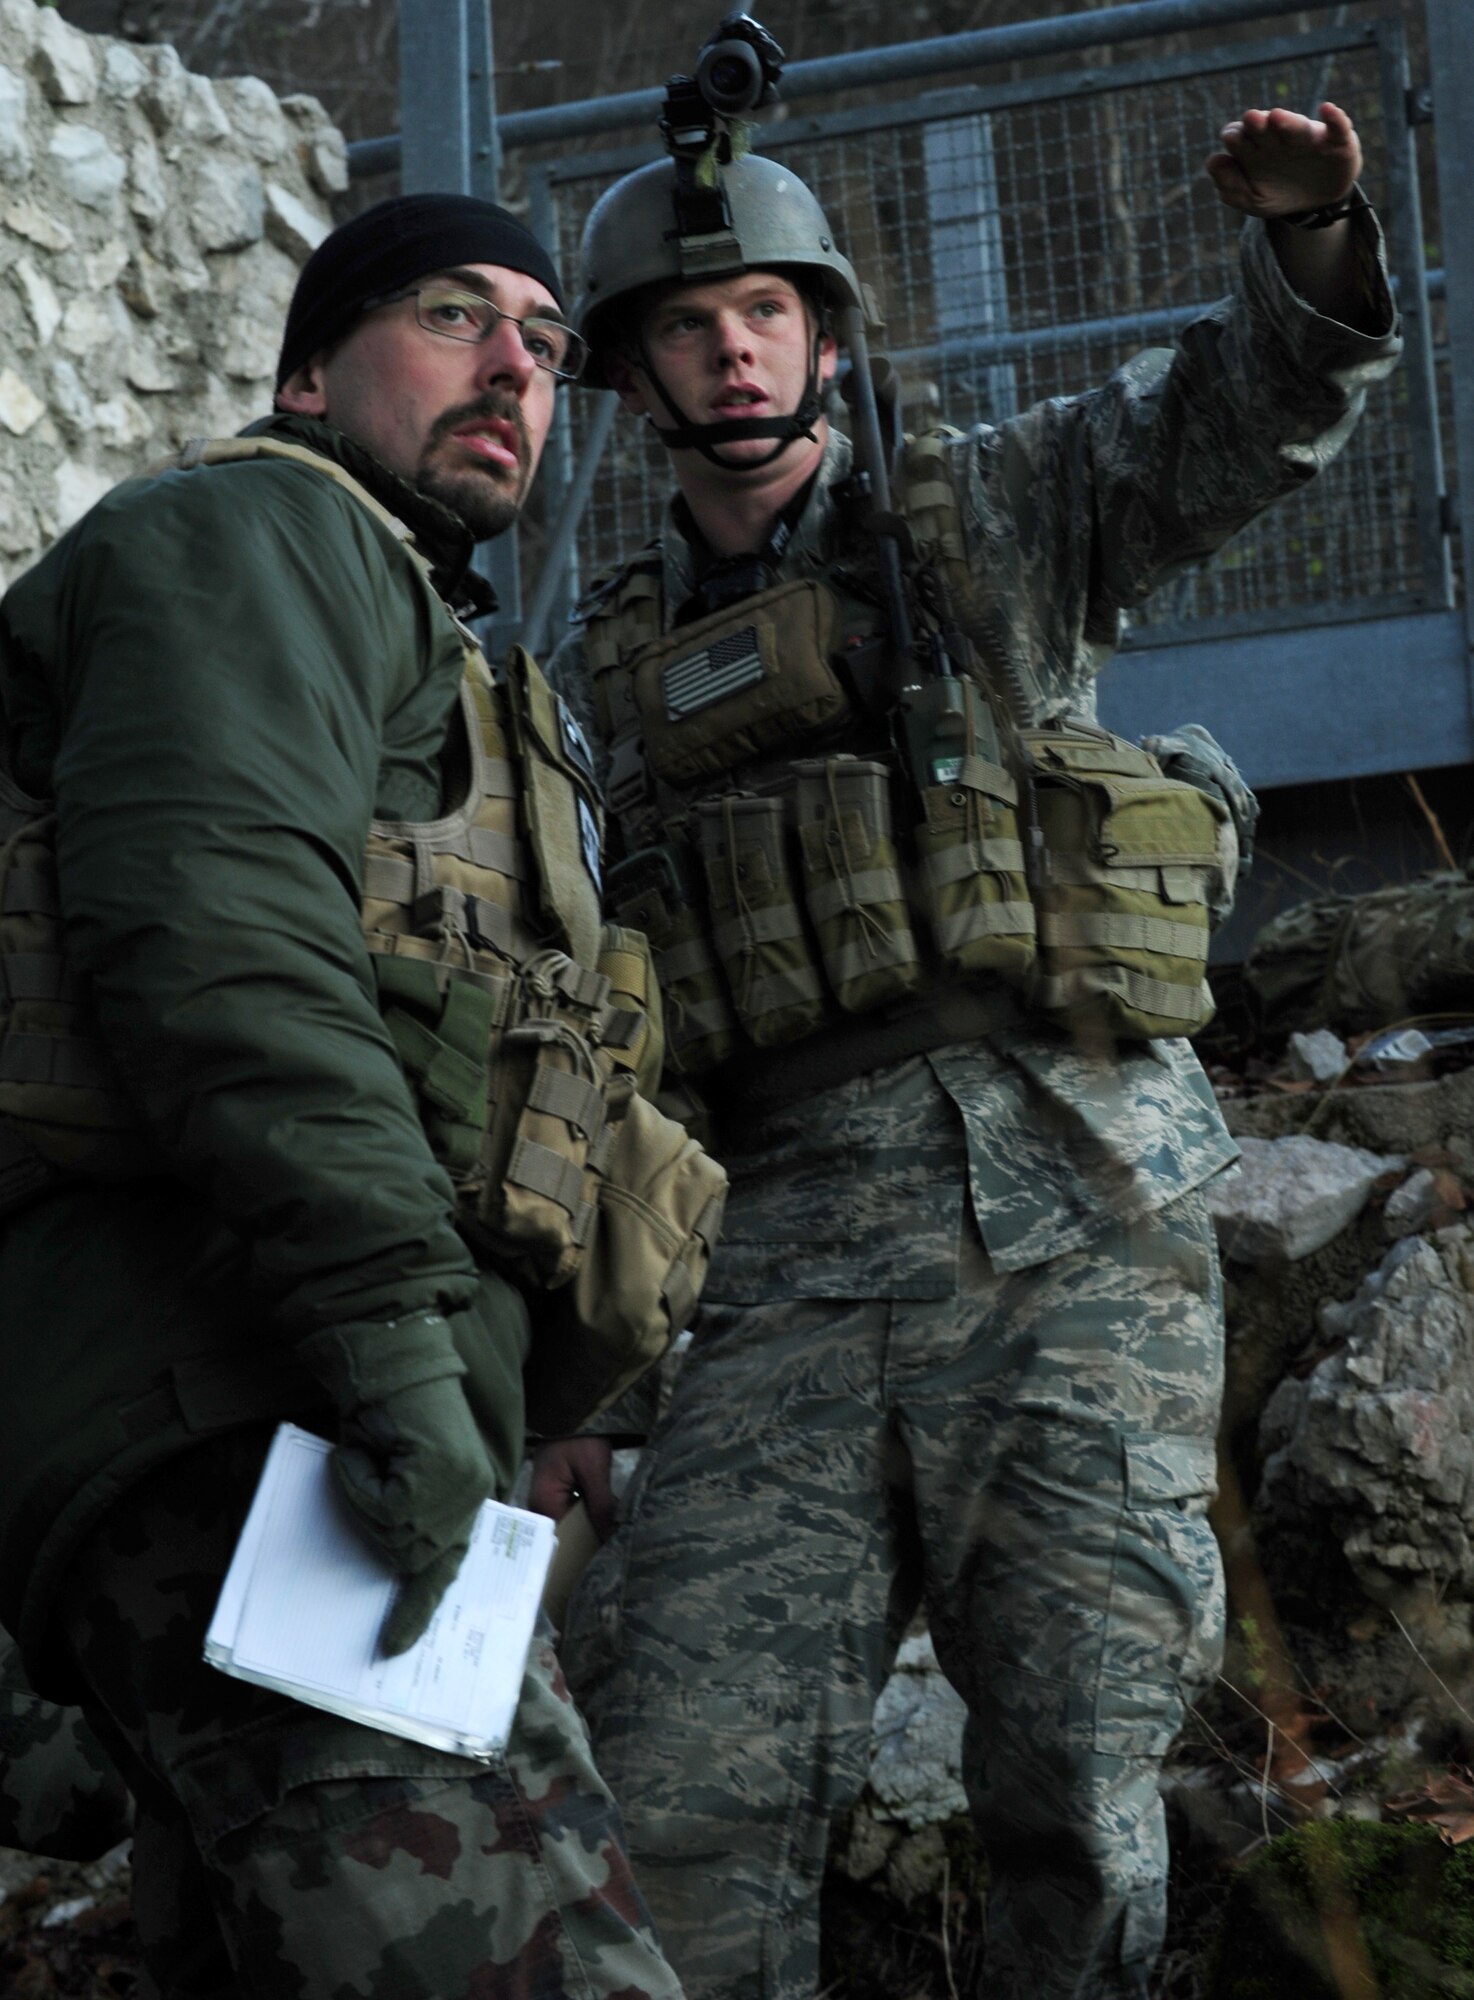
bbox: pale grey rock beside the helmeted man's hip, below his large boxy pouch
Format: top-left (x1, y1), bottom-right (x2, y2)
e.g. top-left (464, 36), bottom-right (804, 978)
top-left (1208, 1132), bottom-right (1402, 1264)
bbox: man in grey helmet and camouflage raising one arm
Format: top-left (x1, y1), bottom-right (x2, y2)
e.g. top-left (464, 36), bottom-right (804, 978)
top-left (534, 86), bottom-right (1398, 2000)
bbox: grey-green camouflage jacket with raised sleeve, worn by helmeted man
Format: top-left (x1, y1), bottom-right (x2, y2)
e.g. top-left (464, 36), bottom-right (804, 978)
top-left (550, 212), bottom-right (1400, 1302)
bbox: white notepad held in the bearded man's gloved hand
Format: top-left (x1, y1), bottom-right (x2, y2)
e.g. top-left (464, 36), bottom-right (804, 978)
top-left (204, 1424), bottom-right (554, 1758)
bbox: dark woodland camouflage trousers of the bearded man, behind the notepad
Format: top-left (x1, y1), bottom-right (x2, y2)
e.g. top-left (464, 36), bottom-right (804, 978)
top-left (58, 1434), bottom-right (680, 2000)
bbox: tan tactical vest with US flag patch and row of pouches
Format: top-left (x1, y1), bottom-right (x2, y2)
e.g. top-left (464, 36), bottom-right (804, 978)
top-left (586, 430), bottom-right (1228, 1076)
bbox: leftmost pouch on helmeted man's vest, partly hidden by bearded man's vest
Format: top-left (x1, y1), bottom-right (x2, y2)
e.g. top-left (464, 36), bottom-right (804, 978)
top-left (608, 844), bottom-right (738, 1096)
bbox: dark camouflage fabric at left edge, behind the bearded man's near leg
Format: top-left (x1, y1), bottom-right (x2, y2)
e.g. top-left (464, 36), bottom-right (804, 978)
top-left (0, 1632), bottom-right (132, 1862)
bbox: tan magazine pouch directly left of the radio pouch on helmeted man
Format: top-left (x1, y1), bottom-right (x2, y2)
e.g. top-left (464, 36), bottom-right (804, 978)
top-left (792, 756), bottom-right (922, 1014)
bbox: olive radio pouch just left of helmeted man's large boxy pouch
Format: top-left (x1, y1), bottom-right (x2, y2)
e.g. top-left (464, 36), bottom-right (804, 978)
top-left (902, 678), bottom-right (1034, 986)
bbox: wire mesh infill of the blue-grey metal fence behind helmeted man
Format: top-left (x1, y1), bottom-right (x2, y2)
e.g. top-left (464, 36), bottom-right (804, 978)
top-left (528, 9), bottom-right (1438, 642)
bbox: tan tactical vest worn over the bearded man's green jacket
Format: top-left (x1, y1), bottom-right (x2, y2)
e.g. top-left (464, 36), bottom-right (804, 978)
top-left (0, 438), bottom-right (726, 1430)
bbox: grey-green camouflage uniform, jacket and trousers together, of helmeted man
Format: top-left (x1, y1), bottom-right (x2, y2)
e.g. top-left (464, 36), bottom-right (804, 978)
top-left (550, 212), bottom-right (1400, 2000)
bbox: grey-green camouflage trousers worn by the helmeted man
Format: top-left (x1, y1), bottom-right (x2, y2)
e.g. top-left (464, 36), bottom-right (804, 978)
top-left (564, 1194), bottom-right (1224, 2000)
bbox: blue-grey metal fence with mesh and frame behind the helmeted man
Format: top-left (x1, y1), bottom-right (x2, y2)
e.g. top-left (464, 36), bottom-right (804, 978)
top-left (364, 0), bottom-right (1474, 784)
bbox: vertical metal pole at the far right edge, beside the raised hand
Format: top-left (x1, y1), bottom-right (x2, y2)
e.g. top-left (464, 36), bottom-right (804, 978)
top-left (1428, 0), bottom-right (1474, 664)
